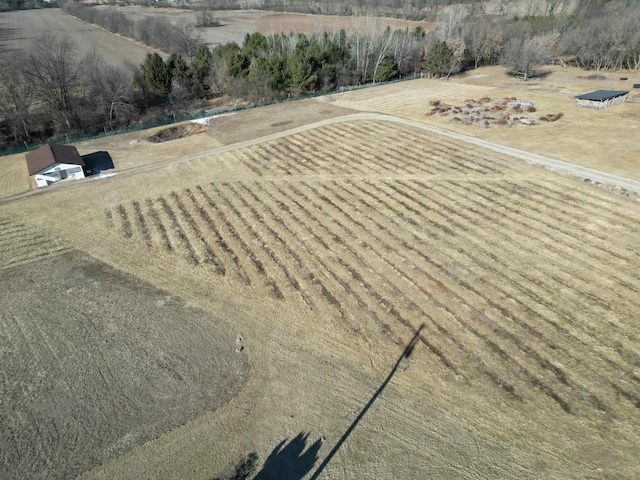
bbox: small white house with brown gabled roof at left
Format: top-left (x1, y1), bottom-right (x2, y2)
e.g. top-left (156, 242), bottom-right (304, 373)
top-left (25, 144), bottom-right (85, 187)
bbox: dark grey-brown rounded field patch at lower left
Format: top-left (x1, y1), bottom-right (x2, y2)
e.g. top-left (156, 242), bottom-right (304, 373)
top-left (0, 242), bottom-right (248, 479)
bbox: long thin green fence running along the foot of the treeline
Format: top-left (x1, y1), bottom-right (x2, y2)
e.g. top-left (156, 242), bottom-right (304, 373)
top-left (0, 75), bottom-right (420, 157)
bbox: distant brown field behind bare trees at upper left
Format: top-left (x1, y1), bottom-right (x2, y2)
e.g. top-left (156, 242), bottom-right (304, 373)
top-left (0, 8), bottom-right (153, 66)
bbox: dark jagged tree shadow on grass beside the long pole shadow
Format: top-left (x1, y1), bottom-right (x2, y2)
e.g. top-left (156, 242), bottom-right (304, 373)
top-left (254, 432), bottom-right (322, 480)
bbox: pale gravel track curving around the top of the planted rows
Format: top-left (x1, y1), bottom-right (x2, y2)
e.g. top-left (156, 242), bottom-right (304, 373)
top-left (0, 112), bottom-right (640, 205)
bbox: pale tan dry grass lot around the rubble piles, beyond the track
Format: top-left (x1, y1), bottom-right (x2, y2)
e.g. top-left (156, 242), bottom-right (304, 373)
top-left (333, 66), bottom-right (640, 180)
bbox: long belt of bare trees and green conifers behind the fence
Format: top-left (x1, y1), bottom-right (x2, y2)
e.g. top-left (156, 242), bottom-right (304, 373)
top-left (0, 0), bottom-right (640, 148)
